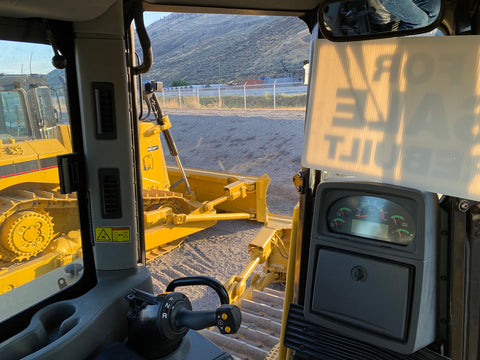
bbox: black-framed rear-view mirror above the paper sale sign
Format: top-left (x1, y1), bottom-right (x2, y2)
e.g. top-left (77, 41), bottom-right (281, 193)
top-left (319, 0), bottom-right (444, 41)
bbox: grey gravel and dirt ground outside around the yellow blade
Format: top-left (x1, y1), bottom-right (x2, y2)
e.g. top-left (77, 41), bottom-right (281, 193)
top-left (147, 109), bottom-right (305, 309)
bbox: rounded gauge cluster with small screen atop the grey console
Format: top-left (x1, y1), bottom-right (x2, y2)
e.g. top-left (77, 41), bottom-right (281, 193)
top-left (327, 195), bottom-right (417, 246)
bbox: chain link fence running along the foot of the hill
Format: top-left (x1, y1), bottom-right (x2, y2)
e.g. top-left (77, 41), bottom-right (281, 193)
top-left (157, 82), bottom-right (307, 110)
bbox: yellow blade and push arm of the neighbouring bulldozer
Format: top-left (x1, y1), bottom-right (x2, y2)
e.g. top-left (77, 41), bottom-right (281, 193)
top-left (144, 166), bottom-right (270, 260)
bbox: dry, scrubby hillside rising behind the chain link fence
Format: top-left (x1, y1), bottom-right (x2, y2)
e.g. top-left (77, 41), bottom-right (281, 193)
top-left (142, 14), bottom-right (310, 86)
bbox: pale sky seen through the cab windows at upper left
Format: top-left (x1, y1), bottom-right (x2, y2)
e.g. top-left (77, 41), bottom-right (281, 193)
top-left (0, 12), bottom-right (170, 74)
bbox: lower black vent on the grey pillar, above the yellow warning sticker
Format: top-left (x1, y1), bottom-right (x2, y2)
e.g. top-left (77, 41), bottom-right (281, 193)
top-left (98, 169), bottom-right (122, 219)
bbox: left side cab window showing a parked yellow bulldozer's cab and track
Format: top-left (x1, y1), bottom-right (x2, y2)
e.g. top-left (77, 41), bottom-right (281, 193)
top-left (0, 41), bottom-right (83, 321)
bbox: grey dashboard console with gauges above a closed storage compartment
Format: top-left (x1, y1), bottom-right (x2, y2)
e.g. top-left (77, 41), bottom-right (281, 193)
top-left (303, 181), bottom-right (439, 354)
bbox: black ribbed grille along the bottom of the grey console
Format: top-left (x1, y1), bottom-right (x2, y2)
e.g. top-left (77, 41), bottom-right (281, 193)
top-left (284, 304), bottom-right (448, 360)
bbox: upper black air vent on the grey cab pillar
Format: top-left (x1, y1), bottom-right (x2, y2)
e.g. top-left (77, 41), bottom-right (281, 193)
top-left (92, 82), bottom-right (117, 139)
